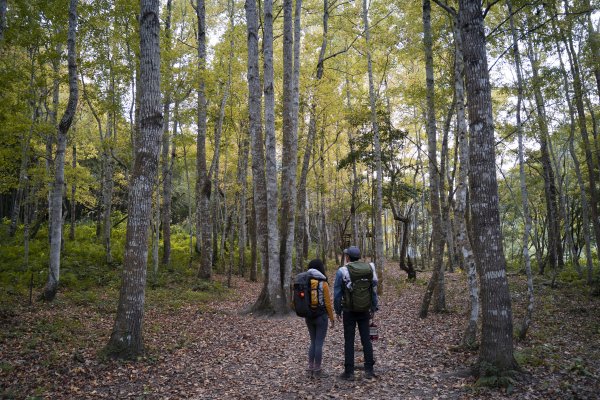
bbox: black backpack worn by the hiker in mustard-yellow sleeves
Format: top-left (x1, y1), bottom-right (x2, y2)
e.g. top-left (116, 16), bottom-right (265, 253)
top-left (292, 272), bottom-right (327, 318)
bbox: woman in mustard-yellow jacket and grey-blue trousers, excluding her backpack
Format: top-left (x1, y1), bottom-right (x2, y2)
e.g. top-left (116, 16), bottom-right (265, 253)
top-left (305, 258), bottom-right (335, 378)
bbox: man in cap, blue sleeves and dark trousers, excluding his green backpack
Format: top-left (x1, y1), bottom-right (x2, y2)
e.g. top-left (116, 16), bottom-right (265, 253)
top-left (333, 246), bottom-right (378, 381)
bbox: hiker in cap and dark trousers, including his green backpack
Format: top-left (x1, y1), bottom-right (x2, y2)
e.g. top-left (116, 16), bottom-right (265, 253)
top-left (333, 246), bottom-right (378, 381)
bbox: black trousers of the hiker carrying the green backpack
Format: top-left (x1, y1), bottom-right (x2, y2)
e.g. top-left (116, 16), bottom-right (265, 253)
top-left (343, 310), bottom-right (375, 373)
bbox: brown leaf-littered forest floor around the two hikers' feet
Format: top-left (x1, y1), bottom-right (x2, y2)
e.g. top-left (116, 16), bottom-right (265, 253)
top-left (0, 264), bottom-right (600, 399)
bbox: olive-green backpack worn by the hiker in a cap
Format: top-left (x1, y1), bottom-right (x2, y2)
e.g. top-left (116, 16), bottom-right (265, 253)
top-left (344, 261), bottom-right (373, 312)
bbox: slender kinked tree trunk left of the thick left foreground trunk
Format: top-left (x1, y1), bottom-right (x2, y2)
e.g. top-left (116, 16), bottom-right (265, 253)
top-left (42, 0), bottom-right (79, 301)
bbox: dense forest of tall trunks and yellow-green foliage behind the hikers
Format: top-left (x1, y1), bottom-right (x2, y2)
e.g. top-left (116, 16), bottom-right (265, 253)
top-left (0, 0), bottom-right (600, 398)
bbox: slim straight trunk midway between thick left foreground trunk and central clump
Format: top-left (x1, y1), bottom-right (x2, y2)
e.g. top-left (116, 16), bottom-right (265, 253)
top-left (196, 0), bottom-right (213, 279)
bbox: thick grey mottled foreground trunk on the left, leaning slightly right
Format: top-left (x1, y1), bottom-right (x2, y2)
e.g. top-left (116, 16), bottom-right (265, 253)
top-left (105, 0), bottom-right (163, 359)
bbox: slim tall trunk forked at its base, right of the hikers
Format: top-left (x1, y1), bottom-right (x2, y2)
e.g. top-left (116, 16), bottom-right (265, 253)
top-left (419, 0), bottom-right (446, 318)
